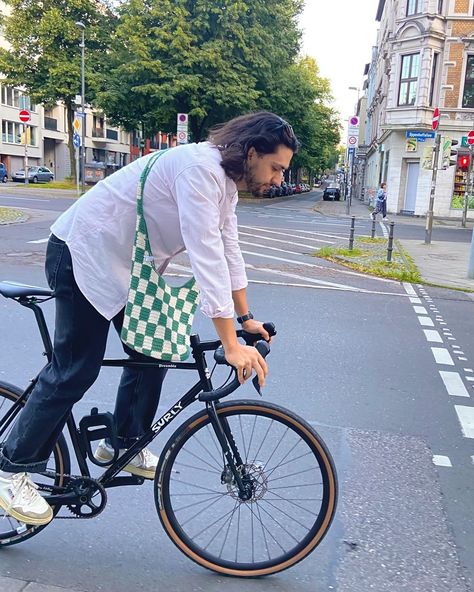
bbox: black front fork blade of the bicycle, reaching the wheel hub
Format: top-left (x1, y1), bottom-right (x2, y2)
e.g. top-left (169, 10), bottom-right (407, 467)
top-left (206, 402), bottom-right (253, 501)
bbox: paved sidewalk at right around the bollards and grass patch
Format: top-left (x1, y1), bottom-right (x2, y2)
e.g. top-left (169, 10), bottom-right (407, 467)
top-left (314, 200), bottom-right (474, 291)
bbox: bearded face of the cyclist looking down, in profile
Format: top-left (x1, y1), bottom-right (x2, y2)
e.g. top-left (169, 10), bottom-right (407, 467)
top-left (244, 144), bottom-right (293, 197)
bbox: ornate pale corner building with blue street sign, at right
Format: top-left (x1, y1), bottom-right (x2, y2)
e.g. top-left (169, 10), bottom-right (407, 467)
top-left (364, 0), bottom-right (474, 218)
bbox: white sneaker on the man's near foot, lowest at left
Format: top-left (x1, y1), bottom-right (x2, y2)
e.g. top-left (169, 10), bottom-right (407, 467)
top-left (0, 473), bottom-right (53, 526)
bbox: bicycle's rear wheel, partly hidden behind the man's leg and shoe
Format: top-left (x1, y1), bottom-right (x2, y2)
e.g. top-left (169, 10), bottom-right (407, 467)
top-left (0, 382), bottom-right (71, 547)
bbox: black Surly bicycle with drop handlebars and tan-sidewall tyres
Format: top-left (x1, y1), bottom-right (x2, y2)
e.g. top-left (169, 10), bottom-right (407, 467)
top-left (0, 282), bottom-right (337, 577)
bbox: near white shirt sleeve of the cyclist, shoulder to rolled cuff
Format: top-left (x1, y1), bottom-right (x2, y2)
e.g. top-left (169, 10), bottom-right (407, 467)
top-left (172, 165), bottom-right (234, 318)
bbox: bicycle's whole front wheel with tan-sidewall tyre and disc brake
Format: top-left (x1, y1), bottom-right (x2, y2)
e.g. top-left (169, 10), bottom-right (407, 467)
top-left (155, 401), bottom-right (337, 577)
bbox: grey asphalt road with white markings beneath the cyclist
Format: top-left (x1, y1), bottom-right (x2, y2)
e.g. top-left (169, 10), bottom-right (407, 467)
top-left (0, 190), bottom-right (474, 592)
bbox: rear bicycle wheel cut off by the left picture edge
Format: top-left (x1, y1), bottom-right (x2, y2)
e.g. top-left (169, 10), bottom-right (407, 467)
top-left (0, 382), bottom-right (71, 547)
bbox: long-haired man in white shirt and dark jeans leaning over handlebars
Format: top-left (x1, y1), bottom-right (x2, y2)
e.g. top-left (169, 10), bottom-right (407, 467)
top-left (0, 112), bottom-right (298, 525)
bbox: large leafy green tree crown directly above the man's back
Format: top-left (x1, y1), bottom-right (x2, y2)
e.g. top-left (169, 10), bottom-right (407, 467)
top-left (99, 0), bottom-right (302, 140)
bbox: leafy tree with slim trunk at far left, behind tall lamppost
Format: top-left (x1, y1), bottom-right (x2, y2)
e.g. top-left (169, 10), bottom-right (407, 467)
top-left (0, 0), bottom-right (113, 180)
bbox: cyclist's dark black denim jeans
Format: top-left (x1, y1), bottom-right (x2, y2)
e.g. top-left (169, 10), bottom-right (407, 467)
top-left (0, 235), bottom-right (166, 473)
